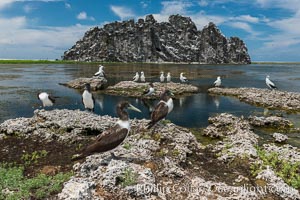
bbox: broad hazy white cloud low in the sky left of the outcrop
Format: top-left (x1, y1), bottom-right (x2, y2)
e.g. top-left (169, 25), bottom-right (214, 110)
top-left (0, 16), bottom-right (91, 59)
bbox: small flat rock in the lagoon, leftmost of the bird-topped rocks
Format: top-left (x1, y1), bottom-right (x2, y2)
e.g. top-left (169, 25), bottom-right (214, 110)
top-left (60, 77), bottom-right (107, 90)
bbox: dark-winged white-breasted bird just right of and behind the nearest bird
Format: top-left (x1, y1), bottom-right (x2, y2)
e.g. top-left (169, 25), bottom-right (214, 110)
top-left (147, 90), bottom-right (174, 129)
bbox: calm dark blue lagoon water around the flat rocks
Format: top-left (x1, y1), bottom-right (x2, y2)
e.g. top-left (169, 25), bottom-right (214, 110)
top-left (0, 64), bottom-right (300, 145)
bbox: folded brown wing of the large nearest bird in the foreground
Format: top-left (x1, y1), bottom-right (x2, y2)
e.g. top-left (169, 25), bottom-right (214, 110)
top-left (83, 125), bottom-right (128, 156)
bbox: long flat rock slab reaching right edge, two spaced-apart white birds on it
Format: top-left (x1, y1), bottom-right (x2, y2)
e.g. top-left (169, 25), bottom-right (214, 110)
top-left (208, 88), bottom-right (300, 112)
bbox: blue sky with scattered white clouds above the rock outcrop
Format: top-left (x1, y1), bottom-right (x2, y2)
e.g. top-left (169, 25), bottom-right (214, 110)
top-left (0, 0), bottom-right (300, 62)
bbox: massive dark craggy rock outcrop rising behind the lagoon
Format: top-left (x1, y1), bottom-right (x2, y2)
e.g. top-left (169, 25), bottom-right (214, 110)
top-left (62, 15), bottom-right (251, 64)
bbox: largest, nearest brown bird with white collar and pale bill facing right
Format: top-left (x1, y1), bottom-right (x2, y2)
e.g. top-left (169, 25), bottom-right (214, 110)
top-left (72, 101), bottom-right (141, 160)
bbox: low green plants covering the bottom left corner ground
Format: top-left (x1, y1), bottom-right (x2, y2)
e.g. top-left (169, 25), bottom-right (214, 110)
top-left (0, 163), bottom-right (73, 200)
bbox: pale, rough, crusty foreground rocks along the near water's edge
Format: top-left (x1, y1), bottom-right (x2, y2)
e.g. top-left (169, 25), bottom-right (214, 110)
top-left (0, 109), bottom-right (300, 199)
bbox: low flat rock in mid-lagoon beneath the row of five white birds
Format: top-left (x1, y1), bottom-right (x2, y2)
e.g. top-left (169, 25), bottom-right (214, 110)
top-left (103, 81), bottom-right (198, 99)
